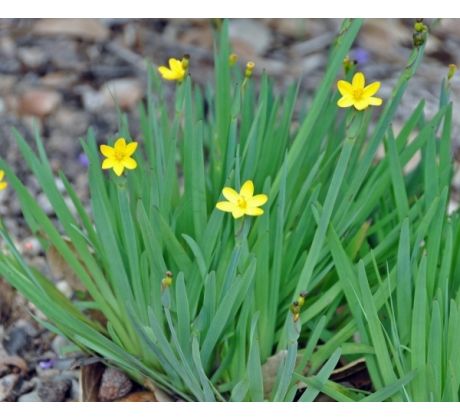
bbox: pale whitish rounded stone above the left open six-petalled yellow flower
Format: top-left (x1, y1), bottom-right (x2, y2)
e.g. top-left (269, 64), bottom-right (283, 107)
top-left (101, 78), bottom-right (144, 110)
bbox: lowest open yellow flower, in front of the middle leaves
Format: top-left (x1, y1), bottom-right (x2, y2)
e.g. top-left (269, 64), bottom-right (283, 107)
top-left (216, 181), bottom-right (268, 219)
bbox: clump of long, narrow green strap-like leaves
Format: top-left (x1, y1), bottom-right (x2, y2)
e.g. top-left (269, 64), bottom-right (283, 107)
top-left (0, 20), bottom-right (460, 401)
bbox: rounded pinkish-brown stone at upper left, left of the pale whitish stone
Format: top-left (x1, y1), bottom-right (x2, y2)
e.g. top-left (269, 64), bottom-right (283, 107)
top-left (18, 88), bottom-right (62, 118)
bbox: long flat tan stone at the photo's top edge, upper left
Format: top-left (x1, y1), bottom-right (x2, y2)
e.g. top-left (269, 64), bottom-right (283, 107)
top-left (32, 19), bottom-right (109, 42)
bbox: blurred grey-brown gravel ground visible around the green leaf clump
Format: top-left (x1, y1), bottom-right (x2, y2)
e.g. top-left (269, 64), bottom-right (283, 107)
top-left (0, 19), bottom-right (460, 401)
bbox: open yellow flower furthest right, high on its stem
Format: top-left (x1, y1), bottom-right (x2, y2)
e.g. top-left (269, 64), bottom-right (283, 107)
top-left (337, 72), bottom-right (382, 111)
